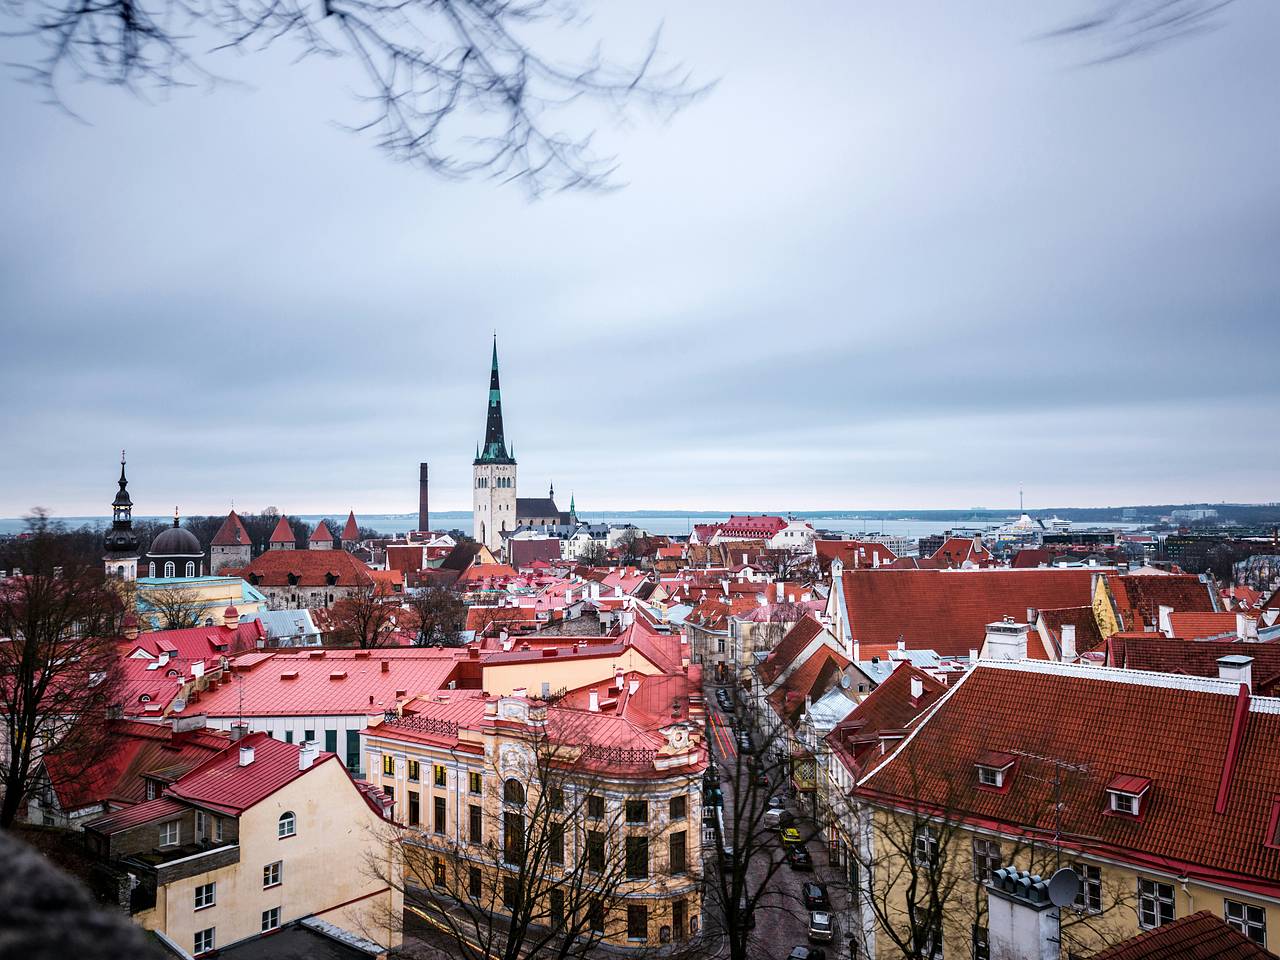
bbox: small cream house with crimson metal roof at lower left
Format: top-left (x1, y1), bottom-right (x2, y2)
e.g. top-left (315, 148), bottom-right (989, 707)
top-left (84, 733), bottom-right (401, 956)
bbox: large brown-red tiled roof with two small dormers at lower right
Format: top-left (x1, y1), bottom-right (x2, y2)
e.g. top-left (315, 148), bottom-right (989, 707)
top-left (858, 660), bottom-right (1280, 896)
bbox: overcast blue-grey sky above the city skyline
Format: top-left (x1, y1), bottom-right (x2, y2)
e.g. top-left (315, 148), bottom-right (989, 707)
top-left (0, 0), bottom-right (1280, 516)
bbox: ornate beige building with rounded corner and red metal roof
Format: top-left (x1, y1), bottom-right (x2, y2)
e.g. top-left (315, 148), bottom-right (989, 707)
top-left (364, 673), bottom-right (707, 950)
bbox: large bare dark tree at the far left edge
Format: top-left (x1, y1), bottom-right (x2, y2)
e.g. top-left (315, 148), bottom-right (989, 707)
top-left (0, 513), bottom-right (122, 827)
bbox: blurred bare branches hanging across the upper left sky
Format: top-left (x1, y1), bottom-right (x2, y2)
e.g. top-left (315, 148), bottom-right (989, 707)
top-left (10, 0), bottom-right (705, 195)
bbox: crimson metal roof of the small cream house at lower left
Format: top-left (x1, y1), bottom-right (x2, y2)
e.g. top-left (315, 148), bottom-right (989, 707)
top-left (165, 732), bottom-right (338, 815)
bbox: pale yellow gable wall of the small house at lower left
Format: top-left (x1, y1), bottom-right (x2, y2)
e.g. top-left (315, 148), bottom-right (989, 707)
top-left (136, 760), bottom-right (399, 951)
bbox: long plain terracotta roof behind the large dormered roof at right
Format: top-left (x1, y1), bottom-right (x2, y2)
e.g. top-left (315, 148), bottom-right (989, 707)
top-left (842, 568), bottom-right (1093, 657)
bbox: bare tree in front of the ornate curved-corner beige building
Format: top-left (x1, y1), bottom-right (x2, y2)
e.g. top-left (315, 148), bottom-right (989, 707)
top-left (371, 707), bottom-right (698, 960)
